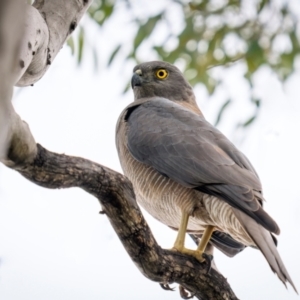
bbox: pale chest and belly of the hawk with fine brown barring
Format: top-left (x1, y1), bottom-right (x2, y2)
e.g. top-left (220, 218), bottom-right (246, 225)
top-left (117, 124), bottom-right (204, 230)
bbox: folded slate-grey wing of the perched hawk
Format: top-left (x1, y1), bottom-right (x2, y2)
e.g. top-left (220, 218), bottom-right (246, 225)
top-left (125, 98), bottom-right (279, 234)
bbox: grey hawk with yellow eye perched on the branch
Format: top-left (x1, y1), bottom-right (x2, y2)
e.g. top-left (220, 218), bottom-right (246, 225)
top-left (116, 61), bottom-right (296, 291)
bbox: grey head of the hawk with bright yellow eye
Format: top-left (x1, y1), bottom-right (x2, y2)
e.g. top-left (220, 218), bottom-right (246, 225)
top-left (131, 61), bottom-right (195, 104)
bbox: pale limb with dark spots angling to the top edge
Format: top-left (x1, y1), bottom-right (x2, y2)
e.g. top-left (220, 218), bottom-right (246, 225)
top-left (16, 0), bottom-right (92, 86)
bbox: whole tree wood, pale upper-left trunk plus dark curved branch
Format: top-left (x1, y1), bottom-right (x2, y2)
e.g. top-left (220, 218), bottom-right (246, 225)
top-left (0, 0), bottom-right (237, 300)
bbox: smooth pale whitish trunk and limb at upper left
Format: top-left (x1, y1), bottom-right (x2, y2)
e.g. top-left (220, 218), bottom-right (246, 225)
top-left (0, 0), bottom-right (92, 163)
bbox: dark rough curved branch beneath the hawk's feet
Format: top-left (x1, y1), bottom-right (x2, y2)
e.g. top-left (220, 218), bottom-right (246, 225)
top-left (8, 144), bottom-right (237, 300)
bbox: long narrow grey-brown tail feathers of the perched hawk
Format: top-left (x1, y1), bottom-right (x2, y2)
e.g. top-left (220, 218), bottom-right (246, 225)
top-left (233, 208), bottom-right (298, 294)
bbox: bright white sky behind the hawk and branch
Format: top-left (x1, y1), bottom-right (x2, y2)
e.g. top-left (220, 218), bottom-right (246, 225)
top-left (0, 2), bottom-right (300, 300)
